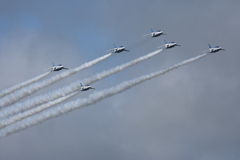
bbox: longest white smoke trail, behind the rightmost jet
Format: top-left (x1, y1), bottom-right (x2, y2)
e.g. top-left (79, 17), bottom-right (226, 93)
top-left (0, 53), bottom-right (207, 137)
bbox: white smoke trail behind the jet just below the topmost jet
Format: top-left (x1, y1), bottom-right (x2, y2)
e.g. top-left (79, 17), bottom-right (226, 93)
top-left (0, 49), bottom-right (162, 118)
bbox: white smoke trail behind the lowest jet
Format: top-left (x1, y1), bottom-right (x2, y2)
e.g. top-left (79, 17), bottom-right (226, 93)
top-left (0, 92), bottom-right (78, 129)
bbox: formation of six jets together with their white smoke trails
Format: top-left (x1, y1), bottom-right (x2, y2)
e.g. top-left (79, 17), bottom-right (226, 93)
top-left (0, 29), bottom-right (224, 137)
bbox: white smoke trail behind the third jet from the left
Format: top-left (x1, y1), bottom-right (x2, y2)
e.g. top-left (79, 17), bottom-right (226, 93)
top-left (0, 53), bottom-right (112, 108)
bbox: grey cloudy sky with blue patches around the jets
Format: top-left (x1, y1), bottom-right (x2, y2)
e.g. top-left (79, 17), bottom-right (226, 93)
top-left (0, 0), bottom-right (240, 160)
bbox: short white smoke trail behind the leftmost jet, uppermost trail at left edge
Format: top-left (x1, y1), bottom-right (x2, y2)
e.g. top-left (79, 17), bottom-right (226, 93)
top-left (0, 72), bottom-right (50, 98)
